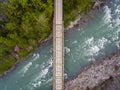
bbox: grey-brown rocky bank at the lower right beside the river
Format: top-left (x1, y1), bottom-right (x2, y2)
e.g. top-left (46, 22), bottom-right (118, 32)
top-left (65, 51), bottom-right (120, 90)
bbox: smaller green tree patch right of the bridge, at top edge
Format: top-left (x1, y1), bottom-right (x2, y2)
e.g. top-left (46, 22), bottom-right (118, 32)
top-left (63, 0), bottom-right (94, 27)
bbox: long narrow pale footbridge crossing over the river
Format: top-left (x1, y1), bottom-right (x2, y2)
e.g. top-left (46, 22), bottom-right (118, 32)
top-left (53, 0), bottom-right (64, 90)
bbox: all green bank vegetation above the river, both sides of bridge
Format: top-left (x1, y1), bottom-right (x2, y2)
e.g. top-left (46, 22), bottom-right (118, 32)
top-left (0, 0), bottom-right (94, 76)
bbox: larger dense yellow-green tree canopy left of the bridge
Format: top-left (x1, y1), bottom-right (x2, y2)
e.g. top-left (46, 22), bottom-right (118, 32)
top-left (0, 0), bottom-right (53, 74)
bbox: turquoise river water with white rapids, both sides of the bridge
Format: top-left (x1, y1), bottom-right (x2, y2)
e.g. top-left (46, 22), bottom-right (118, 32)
top-left (0, 0), bottom-right (120, 90)
